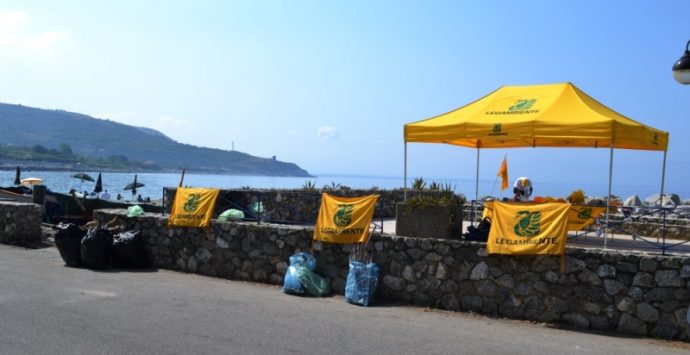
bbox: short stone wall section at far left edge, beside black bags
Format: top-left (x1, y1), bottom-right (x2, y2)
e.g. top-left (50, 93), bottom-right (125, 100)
top-left (0, 201), bottom-right (43, 246)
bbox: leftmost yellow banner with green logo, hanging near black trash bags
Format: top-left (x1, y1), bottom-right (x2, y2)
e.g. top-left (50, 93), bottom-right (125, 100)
top-left (168, 187), bottom-right (218, 228)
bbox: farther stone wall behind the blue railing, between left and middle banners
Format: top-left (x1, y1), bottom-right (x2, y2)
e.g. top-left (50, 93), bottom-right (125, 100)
top-left (165, 188), bottom-right (442, 224)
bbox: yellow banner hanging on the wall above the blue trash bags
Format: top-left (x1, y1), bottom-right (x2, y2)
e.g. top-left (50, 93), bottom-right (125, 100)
top-left (314, 193), bottom-right (379, 244)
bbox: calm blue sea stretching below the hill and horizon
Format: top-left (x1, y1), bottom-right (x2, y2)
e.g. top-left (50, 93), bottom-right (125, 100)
top-left (0, 170), bottom-right (676, 200)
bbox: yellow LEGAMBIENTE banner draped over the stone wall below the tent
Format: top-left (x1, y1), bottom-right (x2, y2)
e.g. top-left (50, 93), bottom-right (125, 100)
top-left (486, 202), bottom-right (570, 255)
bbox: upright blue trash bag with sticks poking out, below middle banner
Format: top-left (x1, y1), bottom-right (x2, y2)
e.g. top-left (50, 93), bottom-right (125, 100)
top-left (345, 260), bottom-right (379, 307)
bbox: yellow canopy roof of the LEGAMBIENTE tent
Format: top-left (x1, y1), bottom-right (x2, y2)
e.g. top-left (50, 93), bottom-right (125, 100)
top-left (405, 83), bottom-right (669, 151)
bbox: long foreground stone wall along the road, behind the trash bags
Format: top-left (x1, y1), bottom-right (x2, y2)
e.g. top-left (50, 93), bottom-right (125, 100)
top-left (94, 210), bottom-right (690, 341)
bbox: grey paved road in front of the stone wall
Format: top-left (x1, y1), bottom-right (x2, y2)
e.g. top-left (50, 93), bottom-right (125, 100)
top-left (0, 245), bottom-right (690, 355)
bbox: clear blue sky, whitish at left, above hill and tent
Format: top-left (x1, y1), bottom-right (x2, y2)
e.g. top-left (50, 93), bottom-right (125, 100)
top-left (0, 0), bottom-right (690, 198)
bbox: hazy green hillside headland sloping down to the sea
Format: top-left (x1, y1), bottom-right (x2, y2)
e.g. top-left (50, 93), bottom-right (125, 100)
top-left (0, 103), bottom-right (310, 176)
